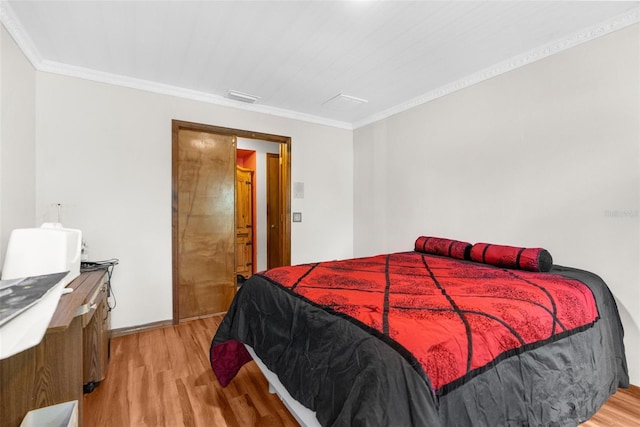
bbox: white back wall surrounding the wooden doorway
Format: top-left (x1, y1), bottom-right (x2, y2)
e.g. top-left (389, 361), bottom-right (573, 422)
top-left (31, 72), bottom-right (353, 328)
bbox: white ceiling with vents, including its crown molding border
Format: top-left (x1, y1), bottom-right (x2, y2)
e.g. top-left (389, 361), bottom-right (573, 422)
top-left (0, 0), bottom-right (640, 128)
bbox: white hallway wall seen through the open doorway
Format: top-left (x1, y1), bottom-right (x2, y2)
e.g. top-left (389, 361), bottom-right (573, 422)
top-left (237, 138), bottom-right (280, 271)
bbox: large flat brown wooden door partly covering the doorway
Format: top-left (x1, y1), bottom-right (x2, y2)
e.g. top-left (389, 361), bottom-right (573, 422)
top-left (173, 129), bottom-right (236, 320)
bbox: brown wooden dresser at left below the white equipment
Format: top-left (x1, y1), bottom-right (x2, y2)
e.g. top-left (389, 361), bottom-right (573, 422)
top-left (0, 270), bottom-right (109, 427)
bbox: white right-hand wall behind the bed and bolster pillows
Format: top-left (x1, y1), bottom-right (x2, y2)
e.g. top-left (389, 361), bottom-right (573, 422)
top-left (354, 25), bottom-right (640, 384)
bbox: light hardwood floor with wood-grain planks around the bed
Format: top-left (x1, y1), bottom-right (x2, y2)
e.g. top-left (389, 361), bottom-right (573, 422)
top-left (83, 316), bottom-right (640, 427)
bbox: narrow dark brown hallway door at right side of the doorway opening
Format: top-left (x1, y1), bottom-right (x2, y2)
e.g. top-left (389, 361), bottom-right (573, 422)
top-left (267, 153), bottom-right (286, 268)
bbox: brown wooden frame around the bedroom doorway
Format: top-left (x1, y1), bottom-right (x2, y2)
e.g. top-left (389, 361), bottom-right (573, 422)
top-left (171, 120), bottom-right (291, 324)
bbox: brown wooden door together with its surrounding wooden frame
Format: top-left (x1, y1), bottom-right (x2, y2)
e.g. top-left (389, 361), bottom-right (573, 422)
top-left (172, 120), bottom-right (291, 323)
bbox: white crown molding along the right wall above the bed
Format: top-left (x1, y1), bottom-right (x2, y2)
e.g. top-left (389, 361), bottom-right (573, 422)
top-left (353, 7), bottom-right (640, 129)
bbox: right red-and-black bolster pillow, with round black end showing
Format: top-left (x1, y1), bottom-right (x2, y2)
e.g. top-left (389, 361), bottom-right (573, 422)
top-left (471, 243), bottom-right (553, 272)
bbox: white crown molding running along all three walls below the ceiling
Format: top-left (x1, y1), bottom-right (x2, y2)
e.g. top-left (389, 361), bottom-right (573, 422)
top-left (0, 1), bottom-right (640, 130)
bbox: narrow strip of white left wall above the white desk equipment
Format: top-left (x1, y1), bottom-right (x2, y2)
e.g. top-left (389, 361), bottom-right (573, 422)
top-left (0, 26), bottom-right (36, 270)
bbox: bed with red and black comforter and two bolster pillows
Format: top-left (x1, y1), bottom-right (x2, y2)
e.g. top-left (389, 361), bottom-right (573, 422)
top-left (210, 236), bottom-right (629, 426)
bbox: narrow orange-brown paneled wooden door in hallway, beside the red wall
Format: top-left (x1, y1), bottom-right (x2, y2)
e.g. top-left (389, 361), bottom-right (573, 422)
top-left (236, 166), bottom-right (254, 278)
